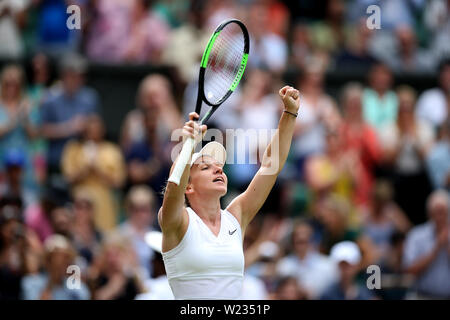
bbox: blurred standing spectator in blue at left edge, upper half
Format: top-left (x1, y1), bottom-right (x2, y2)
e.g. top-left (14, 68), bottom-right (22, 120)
top-left (0, 65), bottom-right (38, 204)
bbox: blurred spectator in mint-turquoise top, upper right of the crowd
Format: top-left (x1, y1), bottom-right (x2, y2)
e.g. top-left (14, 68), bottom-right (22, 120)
top-left (362, 63), bottom-right (398, 137)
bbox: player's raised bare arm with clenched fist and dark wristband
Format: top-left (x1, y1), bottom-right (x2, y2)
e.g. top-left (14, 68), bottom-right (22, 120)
top-left (227, 86), bottom-right (300, 232)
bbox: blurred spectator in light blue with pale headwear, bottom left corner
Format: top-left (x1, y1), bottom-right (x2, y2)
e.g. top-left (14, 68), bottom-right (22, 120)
top-left (22, 235), bottom-right (90, 300)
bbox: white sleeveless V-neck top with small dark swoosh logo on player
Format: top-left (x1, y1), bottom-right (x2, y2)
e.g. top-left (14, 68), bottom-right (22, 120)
top-left (162, 208), bottom-right (244, 300)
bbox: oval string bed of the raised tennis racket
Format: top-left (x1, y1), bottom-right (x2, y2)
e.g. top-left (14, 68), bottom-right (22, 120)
top-left (204, 24), bottom-right (245, 104)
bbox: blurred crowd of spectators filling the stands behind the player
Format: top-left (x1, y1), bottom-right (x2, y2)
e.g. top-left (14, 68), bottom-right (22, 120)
top-left (0, 0), bottom-right (450, 300)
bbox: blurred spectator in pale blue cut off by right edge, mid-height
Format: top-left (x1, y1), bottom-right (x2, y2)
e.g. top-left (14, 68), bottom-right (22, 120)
top-left (426, 118), bottom-right (450, 192)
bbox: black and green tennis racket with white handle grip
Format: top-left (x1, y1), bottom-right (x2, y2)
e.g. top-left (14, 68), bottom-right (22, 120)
top-left (169, 19), bottom-right (250, 185)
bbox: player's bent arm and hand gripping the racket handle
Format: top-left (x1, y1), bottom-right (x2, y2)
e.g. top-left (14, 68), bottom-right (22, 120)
top-left (158, 112), bottom-right (206, 251)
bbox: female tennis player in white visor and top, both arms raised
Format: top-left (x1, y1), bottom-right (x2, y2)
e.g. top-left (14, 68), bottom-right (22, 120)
top-left (158, 86), bottom-right (300, 299)
